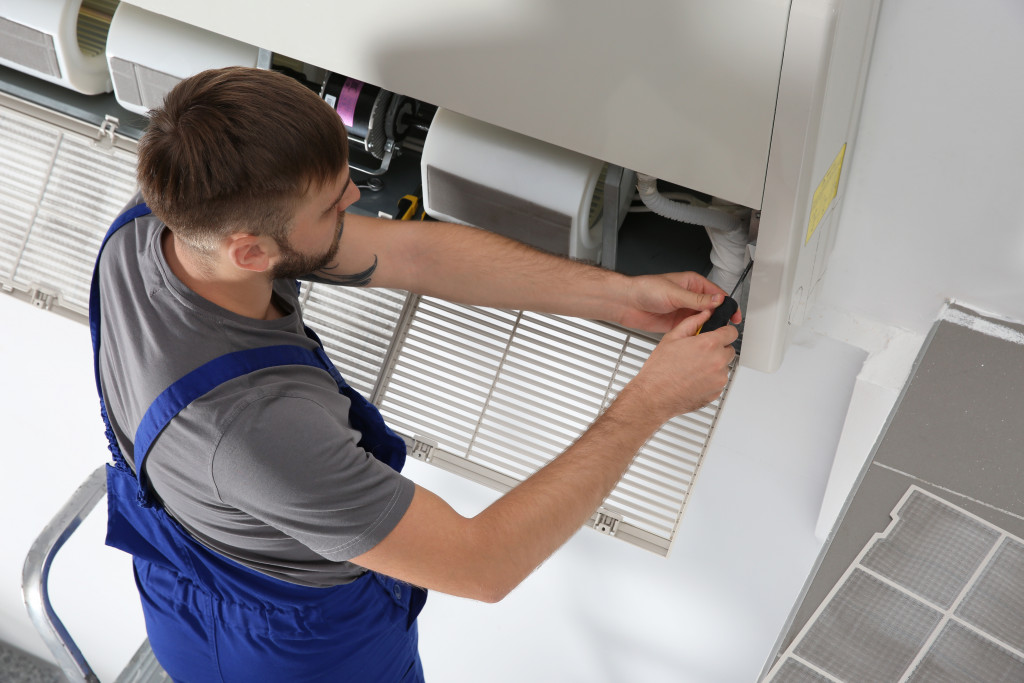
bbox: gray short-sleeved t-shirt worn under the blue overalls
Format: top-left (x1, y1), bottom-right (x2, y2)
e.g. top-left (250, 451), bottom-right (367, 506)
top-left (99, 198), bottom-right (414, 587)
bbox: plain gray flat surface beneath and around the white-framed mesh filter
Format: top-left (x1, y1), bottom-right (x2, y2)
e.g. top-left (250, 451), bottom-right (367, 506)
top-left (777, 306), bottom-right (1024, 663)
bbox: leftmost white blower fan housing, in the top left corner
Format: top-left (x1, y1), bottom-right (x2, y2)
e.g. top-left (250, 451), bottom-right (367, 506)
top-left (0, 0), bottom-right (119, 95)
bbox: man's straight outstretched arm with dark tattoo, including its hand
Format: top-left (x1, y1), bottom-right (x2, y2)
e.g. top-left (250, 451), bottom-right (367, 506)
top-left (315, 214), bottom-right (740, 332)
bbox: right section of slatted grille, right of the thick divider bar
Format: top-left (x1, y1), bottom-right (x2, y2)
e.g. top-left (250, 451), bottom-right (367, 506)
top-left (381, 298), bottom-right (721, 555)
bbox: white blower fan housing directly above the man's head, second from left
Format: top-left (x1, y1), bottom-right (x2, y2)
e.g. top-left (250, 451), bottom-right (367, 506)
top-left (106, 3), bottom-right (259, 115)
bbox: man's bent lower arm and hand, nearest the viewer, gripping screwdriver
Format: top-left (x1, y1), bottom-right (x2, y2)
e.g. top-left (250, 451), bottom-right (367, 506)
top-left (352, 312), bottom-right (736, 602)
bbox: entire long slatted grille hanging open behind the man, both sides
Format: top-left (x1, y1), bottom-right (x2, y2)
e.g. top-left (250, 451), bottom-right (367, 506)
top-left (0, 94), bottom-right (737, 555)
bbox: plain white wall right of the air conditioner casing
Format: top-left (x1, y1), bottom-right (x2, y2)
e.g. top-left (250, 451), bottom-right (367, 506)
top-left (819, 0), bottom-right (1024, 334)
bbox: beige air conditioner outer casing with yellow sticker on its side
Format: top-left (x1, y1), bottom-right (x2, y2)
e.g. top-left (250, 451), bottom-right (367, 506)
top-left (119, 0), bottom-right (880, 371)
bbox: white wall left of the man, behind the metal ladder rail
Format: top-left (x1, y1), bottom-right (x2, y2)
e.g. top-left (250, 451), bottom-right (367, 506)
top-left (0, 305), bottom-right (144, 681)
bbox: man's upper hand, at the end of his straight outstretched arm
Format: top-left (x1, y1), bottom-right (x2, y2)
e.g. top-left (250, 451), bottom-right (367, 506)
top-left (614, 272), bottom-right (742, 336)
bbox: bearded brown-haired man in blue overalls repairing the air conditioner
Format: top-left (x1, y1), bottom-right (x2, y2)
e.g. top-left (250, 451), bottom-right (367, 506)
top-left (90, 69), bottom-right (739, 682)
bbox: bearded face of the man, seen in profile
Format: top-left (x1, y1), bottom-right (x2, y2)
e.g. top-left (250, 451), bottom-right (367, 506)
top-left (270, 166), bottom-right (359, 280)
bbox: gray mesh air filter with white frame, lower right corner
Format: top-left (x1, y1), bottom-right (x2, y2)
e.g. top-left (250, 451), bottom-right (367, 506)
top-left (769, 489), bottom-right (1024, 683)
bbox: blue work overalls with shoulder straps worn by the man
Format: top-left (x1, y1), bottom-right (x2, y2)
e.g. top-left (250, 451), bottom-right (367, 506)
top-left (89, 204), bottom-right (426, 683)
